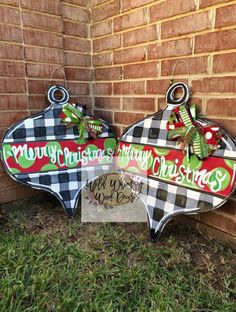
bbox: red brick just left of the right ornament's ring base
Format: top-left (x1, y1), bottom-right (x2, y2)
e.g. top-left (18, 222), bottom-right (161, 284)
top-left (123, 97), bottom-right (155, 112)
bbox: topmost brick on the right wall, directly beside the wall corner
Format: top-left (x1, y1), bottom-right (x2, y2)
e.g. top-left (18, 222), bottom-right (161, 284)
top-left (92, 0), bottom-right (120, 22)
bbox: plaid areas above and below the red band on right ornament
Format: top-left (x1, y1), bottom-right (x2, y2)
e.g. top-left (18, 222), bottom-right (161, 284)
top-left (120, 105), bottom-right (236, 240)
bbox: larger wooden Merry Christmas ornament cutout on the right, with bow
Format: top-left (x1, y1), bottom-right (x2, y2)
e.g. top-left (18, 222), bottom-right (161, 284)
top-left (118, 83), bottom-right (236, 241)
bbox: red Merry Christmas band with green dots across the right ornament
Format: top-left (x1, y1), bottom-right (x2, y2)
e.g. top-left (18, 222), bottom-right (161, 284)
top-left (118, 142), bottom-right (236, 196)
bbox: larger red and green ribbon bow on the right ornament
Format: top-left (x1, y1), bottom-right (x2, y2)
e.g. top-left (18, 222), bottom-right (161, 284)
top-left (167, 105), bottom-right (222, 160)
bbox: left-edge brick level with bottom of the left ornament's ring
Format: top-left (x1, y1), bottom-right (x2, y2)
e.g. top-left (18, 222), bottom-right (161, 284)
top-left (0, 94), bottom-right (28, 110)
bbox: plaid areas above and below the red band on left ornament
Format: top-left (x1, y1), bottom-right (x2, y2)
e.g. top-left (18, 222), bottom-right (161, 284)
top-left (3, 98), bottom-right (115, 215)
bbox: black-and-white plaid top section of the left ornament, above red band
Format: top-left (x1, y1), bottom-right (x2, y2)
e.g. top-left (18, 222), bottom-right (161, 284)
top-left (4, 104), bottom-right (115, 143)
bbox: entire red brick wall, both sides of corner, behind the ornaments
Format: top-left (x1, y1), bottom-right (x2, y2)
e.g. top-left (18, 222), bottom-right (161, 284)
top-left (0, 0), bottom-right (236, 244)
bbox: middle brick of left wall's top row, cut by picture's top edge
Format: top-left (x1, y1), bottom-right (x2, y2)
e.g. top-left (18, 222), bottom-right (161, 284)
top-left (21, 0), bottom-right (61, 15)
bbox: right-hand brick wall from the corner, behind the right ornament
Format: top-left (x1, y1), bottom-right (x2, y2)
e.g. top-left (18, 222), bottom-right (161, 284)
top-left (91, 0), bottom-right (236, 243)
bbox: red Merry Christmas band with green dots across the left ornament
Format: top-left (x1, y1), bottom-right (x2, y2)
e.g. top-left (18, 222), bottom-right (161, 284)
top-left (3, 138), bottom-right (116, 174)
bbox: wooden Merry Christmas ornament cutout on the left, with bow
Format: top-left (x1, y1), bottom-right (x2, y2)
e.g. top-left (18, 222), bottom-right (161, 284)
top-left (1, 85), bottom-right (116, 216)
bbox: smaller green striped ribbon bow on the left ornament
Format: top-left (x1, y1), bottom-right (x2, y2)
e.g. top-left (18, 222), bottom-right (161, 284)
top-left (60, 103), bottom-right (102, 143)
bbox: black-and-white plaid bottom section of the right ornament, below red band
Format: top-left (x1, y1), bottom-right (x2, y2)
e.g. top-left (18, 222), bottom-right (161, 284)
top-left (138, 178), bottom-right (224, 240)
